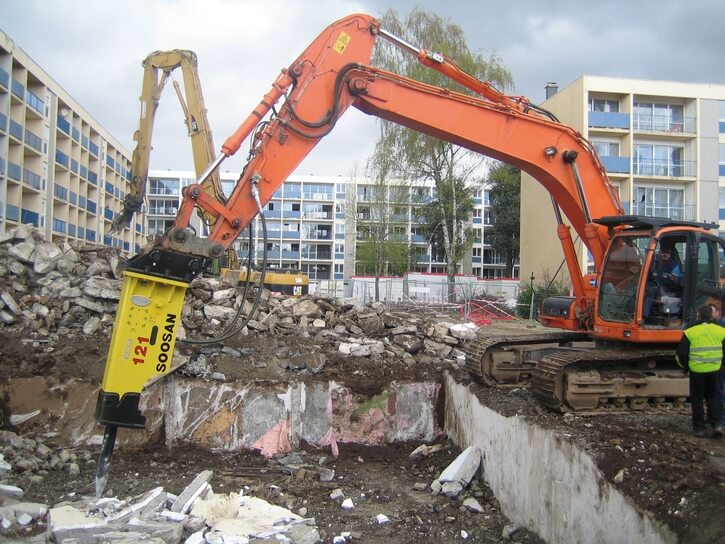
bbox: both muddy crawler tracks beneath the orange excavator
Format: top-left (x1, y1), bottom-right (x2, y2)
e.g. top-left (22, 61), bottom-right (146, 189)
top-left (464, 331), bottom-right (689, 415)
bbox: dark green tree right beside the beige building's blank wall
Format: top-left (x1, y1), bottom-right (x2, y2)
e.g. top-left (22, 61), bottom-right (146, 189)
top-left (487, 163), bottom-right (521, 277)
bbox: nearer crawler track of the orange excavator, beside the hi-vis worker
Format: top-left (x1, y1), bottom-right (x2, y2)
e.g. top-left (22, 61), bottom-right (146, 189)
top-left (531, 346), bottom-right (689, 414)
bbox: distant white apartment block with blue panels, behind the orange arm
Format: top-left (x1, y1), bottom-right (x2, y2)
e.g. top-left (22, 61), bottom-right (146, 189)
top-left (146, 170), bottom-right (504, 292)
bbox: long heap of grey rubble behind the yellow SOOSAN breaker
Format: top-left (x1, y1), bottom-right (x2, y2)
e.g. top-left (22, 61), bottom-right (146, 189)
top-left (0, 226), bottom-right (476, 372)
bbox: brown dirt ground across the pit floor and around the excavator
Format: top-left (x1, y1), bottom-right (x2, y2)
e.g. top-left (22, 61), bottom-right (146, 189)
top-left (0, 325), bottom-right (725, 543)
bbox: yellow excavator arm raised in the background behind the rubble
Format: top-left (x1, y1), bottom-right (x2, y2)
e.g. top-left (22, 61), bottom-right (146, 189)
top-left (111, 49), bottom-right (225, 236)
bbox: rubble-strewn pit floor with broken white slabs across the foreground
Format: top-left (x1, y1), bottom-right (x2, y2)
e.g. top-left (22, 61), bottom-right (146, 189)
top-left (0, 424), bottom-right (520, 544)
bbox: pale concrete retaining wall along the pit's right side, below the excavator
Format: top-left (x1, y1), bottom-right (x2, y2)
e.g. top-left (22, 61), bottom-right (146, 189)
top-left (446, 376), bottom-right (677, 544)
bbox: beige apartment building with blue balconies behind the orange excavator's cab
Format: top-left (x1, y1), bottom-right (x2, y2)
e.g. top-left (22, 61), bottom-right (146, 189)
top-left (520, 76), bottom-right (725, 281)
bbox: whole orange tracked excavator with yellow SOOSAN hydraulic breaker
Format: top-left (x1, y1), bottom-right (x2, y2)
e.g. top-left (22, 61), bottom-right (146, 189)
top-left (96, 14), bottom-right (725, 491)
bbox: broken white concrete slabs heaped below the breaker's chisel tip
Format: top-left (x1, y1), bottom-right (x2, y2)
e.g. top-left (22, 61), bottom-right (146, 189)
top-left (0, 471), bottom-right (320, 544)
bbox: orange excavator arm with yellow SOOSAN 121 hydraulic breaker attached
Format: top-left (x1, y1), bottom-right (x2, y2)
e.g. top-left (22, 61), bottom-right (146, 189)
top-left (96, 14), bottom-right (623, 494)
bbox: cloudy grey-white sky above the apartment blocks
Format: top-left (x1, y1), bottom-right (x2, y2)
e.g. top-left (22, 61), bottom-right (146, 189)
top-left (0, 0), bottom-right (725, 175)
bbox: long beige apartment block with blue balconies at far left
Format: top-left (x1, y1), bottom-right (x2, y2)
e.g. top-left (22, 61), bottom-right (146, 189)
top-left (0, 31), bottom-right (144, 254)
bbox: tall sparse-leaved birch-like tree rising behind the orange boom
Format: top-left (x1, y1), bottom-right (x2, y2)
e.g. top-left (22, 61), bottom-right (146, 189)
top-left (373, 9), bottom-right (512, 296)
